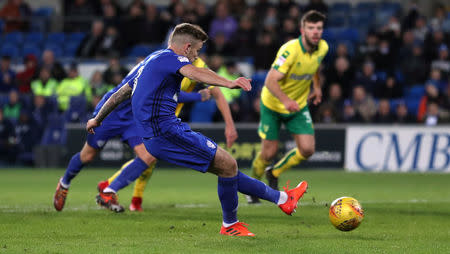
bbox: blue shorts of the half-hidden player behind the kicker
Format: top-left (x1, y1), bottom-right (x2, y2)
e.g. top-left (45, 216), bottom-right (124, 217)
top-left (87, 117), bottom-right (142, 150)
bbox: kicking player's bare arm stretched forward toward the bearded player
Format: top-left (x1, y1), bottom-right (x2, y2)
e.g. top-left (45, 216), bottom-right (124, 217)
top-left (179, 64), bottom-right (252, 91)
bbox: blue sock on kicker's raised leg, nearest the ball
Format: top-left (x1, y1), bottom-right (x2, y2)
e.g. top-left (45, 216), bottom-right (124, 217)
top-left (238, 171), bottom-right (280, 204)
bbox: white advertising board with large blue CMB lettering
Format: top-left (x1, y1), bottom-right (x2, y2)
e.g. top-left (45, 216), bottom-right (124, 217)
top-left (355, 132), bottom-right (450, 171)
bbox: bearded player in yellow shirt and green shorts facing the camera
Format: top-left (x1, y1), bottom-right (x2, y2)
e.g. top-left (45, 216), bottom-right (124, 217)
top-left (248, 11), bottom-right (328, 203)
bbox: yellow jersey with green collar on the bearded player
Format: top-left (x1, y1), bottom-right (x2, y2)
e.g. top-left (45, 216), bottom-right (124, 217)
top-left (261, 36), bottom-right (328, 114)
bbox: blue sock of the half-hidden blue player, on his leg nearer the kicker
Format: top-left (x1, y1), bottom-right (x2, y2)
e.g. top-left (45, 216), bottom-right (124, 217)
top-left (109, 157), bottom-right (148, 192)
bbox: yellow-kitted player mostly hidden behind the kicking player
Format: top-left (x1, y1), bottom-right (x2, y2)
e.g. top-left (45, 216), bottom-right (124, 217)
top-left (97, 58), bottom-right (238, 211)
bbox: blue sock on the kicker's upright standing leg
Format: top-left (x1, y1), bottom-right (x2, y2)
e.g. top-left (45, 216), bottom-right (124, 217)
top-left (217, 176), bottom-right (238, 224)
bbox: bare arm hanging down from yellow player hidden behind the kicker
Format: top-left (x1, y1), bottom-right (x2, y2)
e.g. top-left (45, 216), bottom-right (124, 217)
top-left (211, 87), bottom-right (238, 148)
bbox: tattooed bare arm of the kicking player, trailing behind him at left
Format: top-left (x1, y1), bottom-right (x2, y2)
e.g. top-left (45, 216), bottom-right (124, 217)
top-left (86, 84), bottom-right (132, 134)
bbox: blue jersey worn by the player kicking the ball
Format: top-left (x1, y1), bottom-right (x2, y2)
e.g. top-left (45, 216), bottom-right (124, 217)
top-left (129, 49), bottom-right (190, 138)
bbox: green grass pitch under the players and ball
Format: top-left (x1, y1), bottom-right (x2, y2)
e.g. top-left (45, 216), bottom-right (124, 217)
top-left (0, 168), bottom-right (450, 254)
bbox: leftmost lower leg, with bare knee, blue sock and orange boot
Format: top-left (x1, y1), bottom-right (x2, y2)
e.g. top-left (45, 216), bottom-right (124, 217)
top-left (53, 143), bottom-right (97, 211)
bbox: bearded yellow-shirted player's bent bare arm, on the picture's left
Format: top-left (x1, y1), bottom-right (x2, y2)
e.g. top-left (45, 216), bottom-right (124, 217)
top-left (264, 68), bottom-right (300, 112)
